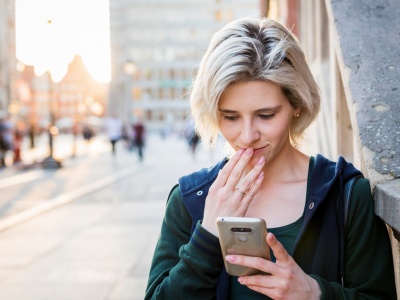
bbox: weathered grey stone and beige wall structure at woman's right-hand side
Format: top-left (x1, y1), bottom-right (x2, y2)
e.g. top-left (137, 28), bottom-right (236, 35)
top-left (298, 0), bottom-right (400, 299)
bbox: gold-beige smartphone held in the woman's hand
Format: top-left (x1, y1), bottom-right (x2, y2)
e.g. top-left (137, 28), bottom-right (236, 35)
top-left (217, 217), bottom-right (271, 276)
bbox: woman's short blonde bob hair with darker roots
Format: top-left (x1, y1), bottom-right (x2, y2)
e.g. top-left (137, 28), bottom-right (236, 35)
top-left (190, 18), bottom-right (320, 146)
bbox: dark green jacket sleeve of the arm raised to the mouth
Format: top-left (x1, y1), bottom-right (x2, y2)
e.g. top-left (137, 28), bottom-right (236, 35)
top-left (145, 187), bottom-right (223, 300)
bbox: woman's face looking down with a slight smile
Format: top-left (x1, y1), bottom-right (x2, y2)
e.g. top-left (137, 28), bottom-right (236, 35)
top-left (218, 81), bottom-right (300, 165)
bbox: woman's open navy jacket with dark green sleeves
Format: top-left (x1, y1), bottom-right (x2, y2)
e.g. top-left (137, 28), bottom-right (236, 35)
top-left (145, 155), bottom-right (396, 300)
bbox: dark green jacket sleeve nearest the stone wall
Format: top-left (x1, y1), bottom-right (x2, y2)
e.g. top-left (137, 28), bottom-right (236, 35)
top-left (312, 178), bottom-right (397, 300)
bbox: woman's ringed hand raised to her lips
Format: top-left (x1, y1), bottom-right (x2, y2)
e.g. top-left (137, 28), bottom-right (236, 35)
top-left (202, 148), bottom-right (265, 236)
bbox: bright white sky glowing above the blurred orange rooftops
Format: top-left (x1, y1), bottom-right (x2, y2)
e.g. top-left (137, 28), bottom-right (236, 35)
top-left (15, 0), bottom-right (111, 82)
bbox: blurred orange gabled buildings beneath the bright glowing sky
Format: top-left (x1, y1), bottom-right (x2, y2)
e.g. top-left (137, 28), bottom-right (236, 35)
top-left (16, 56), bottom-right (108, 131)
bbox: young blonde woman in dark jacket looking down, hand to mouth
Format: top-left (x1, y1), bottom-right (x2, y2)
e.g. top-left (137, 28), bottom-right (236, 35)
top-left (145, 18), bottom-right (396, 299)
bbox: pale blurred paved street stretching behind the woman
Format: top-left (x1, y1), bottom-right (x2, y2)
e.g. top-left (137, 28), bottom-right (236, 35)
top-left (0, 135), bottom-right (222, 300)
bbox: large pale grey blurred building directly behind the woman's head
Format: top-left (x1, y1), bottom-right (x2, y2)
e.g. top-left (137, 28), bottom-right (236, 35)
top-left (108, 0), bottom-right (260, 130)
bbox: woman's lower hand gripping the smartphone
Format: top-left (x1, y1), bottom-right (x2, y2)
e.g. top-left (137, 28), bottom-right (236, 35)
top-left (226, 233), bottom-right (321, 300)
